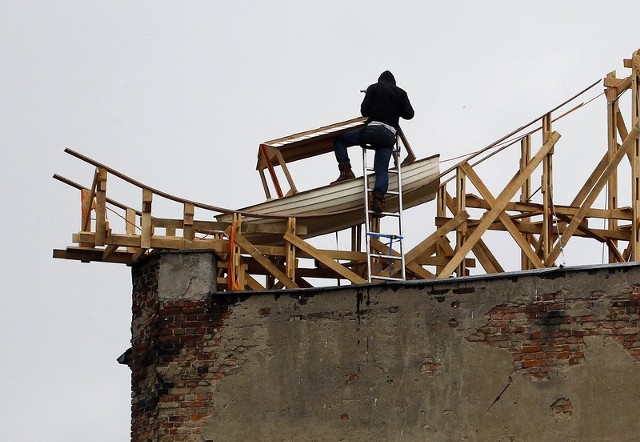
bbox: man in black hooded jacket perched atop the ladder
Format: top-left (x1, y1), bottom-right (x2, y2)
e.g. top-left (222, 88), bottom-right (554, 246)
top-left (331, 71), bottom-right (414, 214)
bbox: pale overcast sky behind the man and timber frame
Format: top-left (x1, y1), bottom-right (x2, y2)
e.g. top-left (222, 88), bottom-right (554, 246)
top-left (0, 0), bottom-right (640, 442)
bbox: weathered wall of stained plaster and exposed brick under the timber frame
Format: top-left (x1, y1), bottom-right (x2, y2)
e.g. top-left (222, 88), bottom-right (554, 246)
top-left (131, 254), bottom-right (640, 442)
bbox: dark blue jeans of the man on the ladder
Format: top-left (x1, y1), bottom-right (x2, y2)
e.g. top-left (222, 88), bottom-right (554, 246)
top-left (333, 125), bottom-right (396, 193)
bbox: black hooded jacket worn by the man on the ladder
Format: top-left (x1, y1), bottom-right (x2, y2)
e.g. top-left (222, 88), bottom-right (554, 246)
top-left (360, 71), bottom-right (414, 129)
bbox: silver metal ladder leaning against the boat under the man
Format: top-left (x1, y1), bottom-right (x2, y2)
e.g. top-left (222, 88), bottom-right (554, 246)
top-left (362, 140), bottom-right (406, 283)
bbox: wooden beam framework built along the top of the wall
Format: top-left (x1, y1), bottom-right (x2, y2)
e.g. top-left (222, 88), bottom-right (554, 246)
top-left (53, 51), bottom-right (640, 291)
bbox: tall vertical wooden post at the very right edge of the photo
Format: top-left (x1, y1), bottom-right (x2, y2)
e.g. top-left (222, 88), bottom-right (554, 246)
top-left (631, 50), bottom-right (640, 261)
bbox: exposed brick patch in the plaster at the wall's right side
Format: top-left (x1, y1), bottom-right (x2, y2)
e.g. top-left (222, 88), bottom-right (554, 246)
top-left (466, 288), bottom-right (640, 378)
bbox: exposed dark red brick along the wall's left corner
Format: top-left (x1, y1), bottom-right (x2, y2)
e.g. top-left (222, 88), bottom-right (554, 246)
top-left (130, 252), bottom-right (220, 441)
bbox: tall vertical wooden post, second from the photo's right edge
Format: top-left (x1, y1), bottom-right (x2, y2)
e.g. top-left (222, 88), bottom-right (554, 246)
top-left (605, 71), bottom-right (619, 263)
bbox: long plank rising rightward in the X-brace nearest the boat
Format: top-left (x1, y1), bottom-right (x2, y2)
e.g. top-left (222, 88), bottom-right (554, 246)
top-left (438, 132), bottom-right (560, 278)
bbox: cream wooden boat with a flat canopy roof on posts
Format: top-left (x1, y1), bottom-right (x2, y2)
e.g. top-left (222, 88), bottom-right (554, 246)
top-left (217, 118), bottom-right (440, 244)
